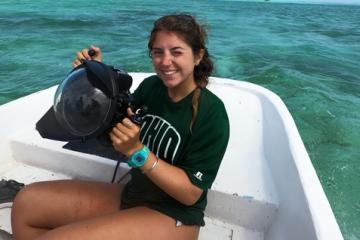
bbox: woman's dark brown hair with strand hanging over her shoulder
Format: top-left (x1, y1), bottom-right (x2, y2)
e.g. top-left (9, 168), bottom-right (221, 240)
top-left (148, 14), bottom-right (214, 130)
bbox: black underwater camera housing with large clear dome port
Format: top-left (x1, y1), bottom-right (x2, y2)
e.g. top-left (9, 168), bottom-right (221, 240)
top-left (36, 60), bottom-right (144, 145)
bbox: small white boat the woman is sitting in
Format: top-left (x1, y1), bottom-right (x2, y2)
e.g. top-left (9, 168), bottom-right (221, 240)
top-left (0, 73), bottom-right (343, 240)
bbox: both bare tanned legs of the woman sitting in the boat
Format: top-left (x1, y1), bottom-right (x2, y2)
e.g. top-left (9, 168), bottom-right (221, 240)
top-left (12, 180), bottom-right (199, 240)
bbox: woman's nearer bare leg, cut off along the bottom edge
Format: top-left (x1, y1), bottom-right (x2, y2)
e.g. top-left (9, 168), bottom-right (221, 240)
top-left (38, 207), bottom-right (199, 240)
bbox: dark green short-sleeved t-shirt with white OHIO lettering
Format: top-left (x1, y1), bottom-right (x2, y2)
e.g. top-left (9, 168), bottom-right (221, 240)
top-left (122, 76), bottom-right (229, 226)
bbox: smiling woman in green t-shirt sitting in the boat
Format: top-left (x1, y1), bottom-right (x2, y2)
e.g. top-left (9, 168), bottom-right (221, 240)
top-left (12, 15), bottom-right (229, 240)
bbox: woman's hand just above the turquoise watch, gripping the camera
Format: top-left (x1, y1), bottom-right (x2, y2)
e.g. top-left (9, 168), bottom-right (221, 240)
top-left (110, 108), bottom-right (143, 157)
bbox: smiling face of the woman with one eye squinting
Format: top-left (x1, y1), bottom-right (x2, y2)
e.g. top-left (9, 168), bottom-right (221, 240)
top-left (151, 31), bottom-right (202, 94)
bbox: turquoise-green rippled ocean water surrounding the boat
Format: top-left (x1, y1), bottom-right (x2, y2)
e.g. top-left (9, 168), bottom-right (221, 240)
top-left (0, 0), bottom-right (360, 240)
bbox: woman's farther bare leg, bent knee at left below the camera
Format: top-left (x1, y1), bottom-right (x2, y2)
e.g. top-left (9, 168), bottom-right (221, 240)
top-left (11, 180), bottom-right (122, 240)
